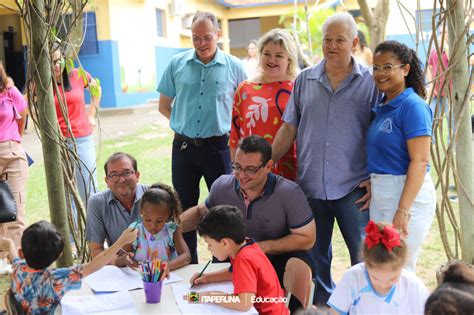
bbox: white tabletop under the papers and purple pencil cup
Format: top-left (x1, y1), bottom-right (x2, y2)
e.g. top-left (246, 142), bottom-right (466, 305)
top-left (58, 263), bottom-right (230, 314)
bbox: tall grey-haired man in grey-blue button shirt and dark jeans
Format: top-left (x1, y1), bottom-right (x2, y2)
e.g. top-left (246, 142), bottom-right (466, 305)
top-left (273, 13), bottom-right (378, 304)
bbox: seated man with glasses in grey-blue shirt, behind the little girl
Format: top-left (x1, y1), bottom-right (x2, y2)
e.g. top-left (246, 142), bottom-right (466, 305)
top-left (86, 152), bottom-right (148, 266)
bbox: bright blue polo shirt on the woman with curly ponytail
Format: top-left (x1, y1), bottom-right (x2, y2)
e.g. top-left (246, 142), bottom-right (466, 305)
top-left (367, 88), bottom-right (433, 175)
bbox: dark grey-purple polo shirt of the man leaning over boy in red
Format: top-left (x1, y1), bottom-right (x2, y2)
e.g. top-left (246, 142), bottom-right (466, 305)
top-left (206, 173), bottom-right (313, 242)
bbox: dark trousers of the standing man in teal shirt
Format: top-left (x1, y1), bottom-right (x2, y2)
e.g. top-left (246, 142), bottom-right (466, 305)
top-left (171, 136), bottom-right (231, 264)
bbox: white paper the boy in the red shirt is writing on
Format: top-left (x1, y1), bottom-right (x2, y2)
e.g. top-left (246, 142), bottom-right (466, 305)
top-left (171, 282), bottom-right (258, 314)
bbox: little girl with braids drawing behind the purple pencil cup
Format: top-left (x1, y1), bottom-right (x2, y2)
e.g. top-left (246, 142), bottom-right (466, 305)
top-left (122, 183), bottom-right (191, 270)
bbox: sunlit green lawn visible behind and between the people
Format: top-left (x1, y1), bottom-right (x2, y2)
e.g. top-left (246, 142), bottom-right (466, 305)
top-left (23, 119), bottom-right (447, 290)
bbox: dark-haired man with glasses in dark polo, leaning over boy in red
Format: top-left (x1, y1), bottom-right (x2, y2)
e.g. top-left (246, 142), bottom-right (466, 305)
top-left (181, 135), bottom-right (316, 282)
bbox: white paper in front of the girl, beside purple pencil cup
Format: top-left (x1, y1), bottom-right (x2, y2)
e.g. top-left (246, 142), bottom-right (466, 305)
top-left (85, 265), bottom-right (183, 292)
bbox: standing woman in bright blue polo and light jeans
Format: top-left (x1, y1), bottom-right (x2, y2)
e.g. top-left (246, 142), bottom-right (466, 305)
top-left (367, 41), bottom-right (436, 272)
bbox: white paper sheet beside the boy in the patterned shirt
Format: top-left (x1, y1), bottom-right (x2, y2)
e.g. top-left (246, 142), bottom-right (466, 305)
top-left (61, 291), bottom-right (138, 315)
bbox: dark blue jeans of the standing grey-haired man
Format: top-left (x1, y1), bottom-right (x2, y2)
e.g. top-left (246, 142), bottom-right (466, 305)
top-left (308, 188), bottom-right (369, 306)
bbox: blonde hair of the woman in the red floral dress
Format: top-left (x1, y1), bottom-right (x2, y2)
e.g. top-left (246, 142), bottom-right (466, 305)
top-left (257, 28), bottom-right (300, 79)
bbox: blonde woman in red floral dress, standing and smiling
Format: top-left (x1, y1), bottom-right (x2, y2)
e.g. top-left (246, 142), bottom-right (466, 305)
top-left (229, 29), bottom-right (299, 180)
